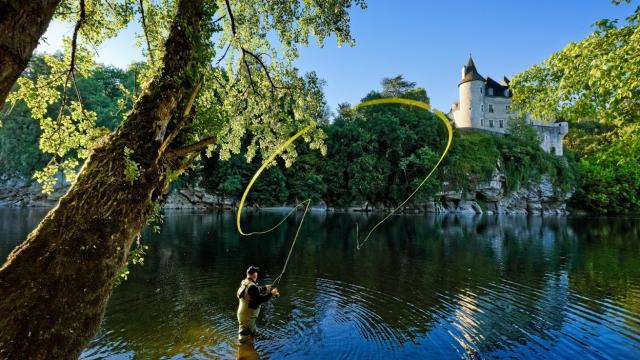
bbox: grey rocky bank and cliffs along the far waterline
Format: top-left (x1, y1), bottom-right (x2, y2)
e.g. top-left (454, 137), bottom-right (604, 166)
top-left (0, 170), bottom-right (573, 215)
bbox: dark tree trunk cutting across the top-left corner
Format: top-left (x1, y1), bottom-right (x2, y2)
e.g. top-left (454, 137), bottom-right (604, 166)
top-left (0, 0), bottom-right (60, 107)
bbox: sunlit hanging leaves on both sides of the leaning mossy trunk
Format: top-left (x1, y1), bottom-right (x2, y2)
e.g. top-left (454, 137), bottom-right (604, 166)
top-left (2, 0), bottom-right (366, 191)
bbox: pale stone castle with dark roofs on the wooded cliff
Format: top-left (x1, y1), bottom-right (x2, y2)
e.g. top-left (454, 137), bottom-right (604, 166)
top-left (449, 56), bottom-right (569, 156)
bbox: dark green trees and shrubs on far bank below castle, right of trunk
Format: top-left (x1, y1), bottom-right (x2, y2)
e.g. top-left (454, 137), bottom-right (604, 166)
top-left (198, 77), bottom-right (577, 207)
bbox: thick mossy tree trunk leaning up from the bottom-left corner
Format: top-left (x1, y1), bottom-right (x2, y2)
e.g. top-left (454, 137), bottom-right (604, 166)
top-left (0, 0), bottom-right (208, 359)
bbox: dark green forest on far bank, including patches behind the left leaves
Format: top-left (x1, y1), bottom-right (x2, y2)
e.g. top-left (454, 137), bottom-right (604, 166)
top-left (0, 60), bottom-right (579, 207)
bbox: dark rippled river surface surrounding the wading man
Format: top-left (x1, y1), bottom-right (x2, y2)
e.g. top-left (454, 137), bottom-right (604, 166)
top-left (0, 209), bottom-right (640, 359)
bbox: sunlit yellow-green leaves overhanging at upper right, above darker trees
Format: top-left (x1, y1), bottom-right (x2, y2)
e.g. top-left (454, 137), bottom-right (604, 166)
top-left (511, 3), bottom-right (640, 123)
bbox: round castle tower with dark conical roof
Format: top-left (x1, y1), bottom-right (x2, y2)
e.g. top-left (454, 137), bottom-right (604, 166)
top-left (455, 55), bottom-right (485, 128)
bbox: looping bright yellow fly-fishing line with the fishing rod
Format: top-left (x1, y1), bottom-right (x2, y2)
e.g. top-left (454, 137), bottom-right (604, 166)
top-left (236, 98), bottom-right (453, 285)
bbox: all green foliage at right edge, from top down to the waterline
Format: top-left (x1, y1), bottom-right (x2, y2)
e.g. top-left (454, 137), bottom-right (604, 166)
top-left (511, 0), bottom-right (640, 213)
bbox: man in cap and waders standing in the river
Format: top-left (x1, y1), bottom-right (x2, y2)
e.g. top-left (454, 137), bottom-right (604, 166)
top-left (236, 266), bottom-right (280, 343)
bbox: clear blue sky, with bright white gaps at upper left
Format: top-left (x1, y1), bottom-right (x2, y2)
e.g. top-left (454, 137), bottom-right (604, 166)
top-left (38, 0), bottom-right (638, 112)
